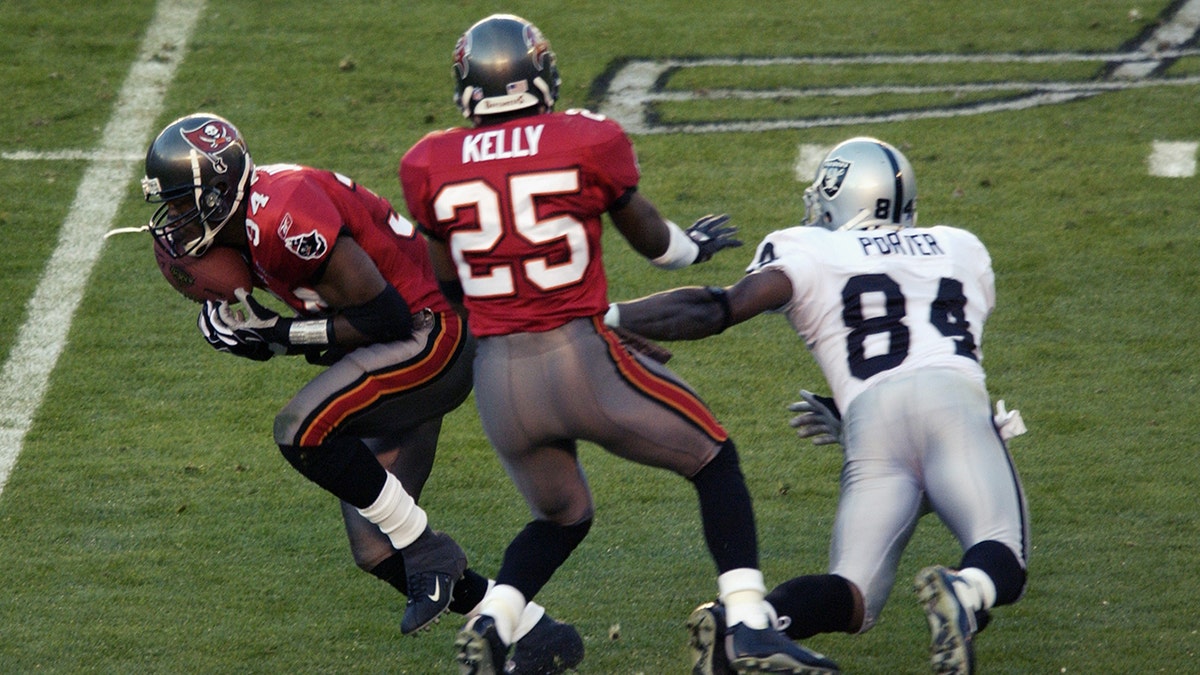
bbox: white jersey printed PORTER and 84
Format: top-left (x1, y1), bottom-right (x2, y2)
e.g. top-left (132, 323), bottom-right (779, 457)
top-left (746, 226), bottom-right (996, 411)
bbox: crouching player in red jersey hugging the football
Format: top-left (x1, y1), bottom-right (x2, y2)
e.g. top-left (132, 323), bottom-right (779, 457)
top-left (143, 113), bottom-right (582, 673)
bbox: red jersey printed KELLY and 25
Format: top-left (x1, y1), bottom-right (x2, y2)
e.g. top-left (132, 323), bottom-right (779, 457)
top-left (400, 110), bottom-right (640, 336)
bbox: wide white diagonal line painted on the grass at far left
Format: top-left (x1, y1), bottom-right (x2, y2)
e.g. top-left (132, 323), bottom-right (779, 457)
top-left (0, 0), bottom-right (204, 495)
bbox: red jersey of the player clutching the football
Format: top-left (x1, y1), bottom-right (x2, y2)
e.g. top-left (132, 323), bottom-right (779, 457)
top-left (245, 165), bottom-right (449, 315)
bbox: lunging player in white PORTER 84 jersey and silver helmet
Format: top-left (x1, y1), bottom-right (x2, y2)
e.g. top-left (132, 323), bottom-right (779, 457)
top-left (606, 137), bottom-right (1028, 674)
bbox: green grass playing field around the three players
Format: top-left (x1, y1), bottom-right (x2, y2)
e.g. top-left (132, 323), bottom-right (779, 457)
top-left (0, 0), bottom-right (1200, 675)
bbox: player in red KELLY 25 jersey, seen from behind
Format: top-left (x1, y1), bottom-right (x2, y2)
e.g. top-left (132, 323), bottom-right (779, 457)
top-left (400, 14), bottom-right (836, 674)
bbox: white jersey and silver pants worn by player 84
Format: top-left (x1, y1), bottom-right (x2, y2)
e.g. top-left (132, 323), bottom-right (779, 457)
top-left (748, 226), bottom-right (1028, 631)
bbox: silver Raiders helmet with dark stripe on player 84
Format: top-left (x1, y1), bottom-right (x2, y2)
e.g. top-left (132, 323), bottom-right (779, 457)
top-left (804, 136), bottom-right (917, 231)
